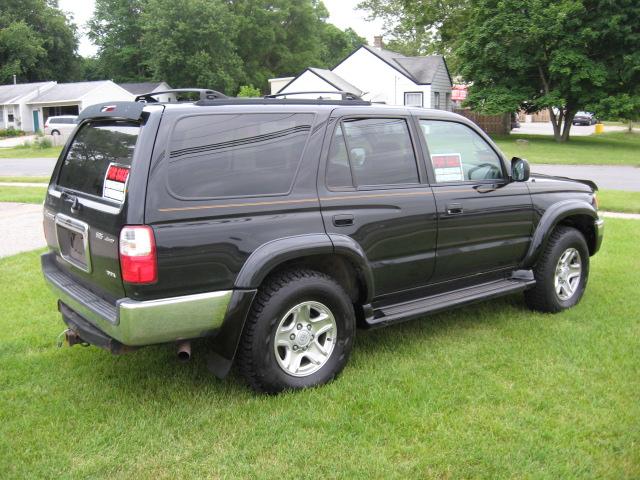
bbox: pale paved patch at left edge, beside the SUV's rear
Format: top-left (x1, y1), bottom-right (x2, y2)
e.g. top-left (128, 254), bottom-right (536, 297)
top-left (0, 203), bottom-right (46, 257)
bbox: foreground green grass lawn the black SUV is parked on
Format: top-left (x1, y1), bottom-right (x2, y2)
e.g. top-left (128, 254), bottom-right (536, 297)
top-left (0, 220), bottom-right (640, 480)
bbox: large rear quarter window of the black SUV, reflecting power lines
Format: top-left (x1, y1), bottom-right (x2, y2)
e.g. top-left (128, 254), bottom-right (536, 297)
top-left (169, 113), bottom-right (313, 198)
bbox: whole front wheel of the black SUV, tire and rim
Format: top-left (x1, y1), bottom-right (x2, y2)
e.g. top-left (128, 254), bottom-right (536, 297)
top-left (525, 226), bottom-right (589, 313)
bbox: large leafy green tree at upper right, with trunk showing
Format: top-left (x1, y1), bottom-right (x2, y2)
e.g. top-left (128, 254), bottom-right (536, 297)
top-left (456, 0), bottom-right (640, 141)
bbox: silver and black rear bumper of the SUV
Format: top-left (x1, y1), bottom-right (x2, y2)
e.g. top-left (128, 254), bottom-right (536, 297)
top-left (41, 253), bottom-right (233, 344)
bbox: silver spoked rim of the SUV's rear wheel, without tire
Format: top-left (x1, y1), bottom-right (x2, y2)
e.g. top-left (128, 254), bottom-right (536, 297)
top-left (273, 301), bottom-right (338, 377)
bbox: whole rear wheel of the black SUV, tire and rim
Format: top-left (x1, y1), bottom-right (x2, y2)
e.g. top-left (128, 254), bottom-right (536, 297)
top-left (238, 269), bottom-right (355, 393)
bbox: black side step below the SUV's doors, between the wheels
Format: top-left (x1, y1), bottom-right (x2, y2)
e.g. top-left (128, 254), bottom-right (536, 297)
top-left (366, 272), bottom-right (536, 327)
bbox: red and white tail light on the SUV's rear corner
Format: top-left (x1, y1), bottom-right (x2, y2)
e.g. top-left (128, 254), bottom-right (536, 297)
top-left (120, 225), bottom-right (158, 283)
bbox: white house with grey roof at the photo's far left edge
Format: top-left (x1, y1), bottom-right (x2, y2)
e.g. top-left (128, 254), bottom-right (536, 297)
top-left (0, 82), bottom-right (56, 131)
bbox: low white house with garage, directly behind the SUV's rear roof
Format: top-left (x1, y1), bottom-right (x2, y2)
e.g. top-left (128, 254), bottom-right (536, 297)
top-left (22, 80), bottom-right (135, 131)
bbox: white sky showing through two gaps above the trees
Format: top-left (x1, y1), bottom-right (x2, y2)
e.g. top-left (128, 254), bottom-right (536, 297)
top-left (58, 0), bottom-right (382, 57)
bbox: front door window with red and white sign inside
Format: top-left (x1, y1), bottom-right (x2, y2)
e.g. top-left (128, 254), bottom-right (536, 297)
top-left (420, 120), bottom-right (504, 183)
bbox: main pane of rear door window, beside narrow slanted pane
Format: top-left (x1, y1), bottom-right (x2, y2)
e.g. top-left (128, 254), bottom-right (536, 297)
top-left (342, 118), bottom-right (419, 186)
